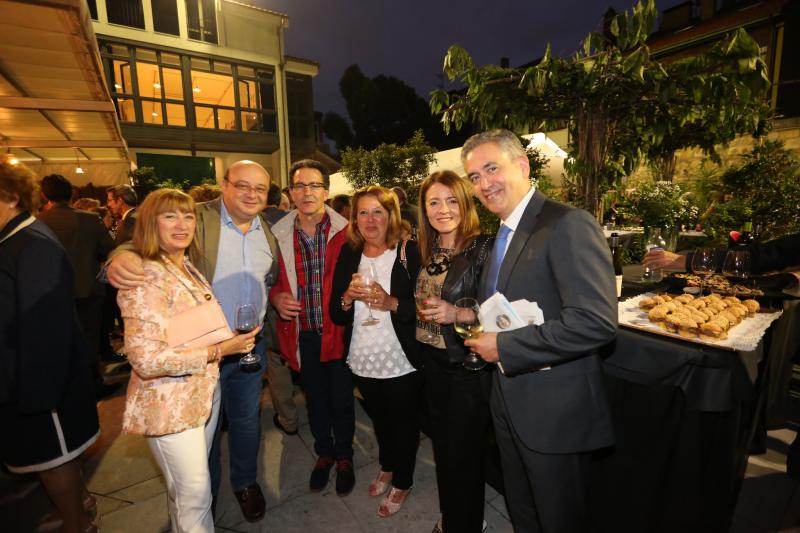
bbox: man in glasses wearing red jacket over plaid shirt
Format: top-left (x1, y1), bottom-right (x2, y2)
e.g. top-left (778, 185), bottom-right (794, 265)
top-left (270, 159), bottom-right (355, 496)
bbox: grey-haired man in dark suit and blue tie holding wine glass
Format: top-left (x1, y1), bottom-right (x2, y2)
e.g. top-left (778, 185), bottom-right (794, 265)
top-left (461, 130), bottom-right (617, 532)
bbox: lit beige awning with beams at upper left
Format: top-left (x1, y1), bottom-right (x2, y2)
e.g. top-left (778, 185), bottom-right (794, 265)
top-left (0, 0), bottom-right (130, 186)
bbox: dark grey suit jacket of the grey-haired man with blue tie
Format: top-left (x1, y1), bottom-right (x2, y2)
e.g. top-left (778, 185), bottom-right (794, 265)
top-left (481, 191), bottom-right (617, 453)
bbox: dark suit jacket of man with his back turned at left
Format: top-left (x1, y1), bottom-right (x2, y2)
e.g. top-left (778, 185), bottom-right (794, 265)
top-left (39, 205), bottom-right (114, 298)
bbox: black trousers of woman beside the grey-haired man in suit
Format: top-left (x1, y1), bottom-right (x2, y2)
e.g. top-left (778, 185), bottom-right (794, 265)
top-left (424, 348), bottom-right (490, 533)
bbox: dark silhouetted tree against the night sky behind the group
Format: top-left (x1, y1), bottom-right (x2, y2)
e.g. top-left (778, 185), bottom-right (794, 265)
top-left (322, 65), bottom-right (476, 152)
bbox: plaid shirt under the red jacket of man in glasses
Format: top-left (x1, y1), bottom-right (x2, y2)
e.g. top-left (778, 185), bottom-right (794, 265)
top-left (294, 213), bottom-right (331, 331)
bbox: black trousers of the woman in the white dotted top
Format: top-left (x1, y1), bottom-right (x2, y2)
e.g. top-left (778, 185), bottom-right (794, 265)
top-left (353, 371), bottom-right (423, 490)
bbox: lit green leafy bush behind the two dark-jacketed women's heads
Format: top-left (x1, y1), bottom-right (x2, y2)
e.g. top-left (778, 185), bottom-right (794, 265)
top-left (341, 131), bottom-right (434, 203)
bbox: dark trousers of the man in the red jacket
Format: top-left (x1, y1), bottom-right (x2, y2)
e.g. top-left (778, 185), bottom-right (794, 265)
top-left (298, 331), bottom-right (356, 460)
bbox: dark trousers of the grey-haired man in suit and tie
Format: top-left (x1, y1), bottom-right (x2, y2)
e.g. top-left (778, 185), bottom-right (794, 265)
top-left (491, 374), bottom-right (591, 533)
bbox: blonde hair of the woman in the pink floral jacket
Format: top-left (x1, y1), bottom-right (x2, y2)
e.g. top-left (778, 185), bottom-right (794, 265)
top-left (133, 189), bottom-right (199, 260)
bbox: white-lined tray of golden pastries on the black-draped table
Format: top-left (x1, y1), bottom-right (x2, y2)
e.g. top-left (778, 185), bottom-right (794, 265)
top-left (619, 293), bottom-right (781, 350)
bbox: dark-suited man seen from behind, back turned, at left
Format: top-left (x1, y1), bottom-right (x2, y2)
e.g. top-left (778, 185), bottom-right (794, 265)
top-left (39, 174), bottom-right (119, 399)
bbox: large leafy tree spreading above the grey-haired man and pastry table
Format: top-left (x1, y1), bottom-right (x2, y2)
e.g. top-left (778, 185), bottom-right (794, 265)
top-left (430, 0), bottom-right (769, 216)
